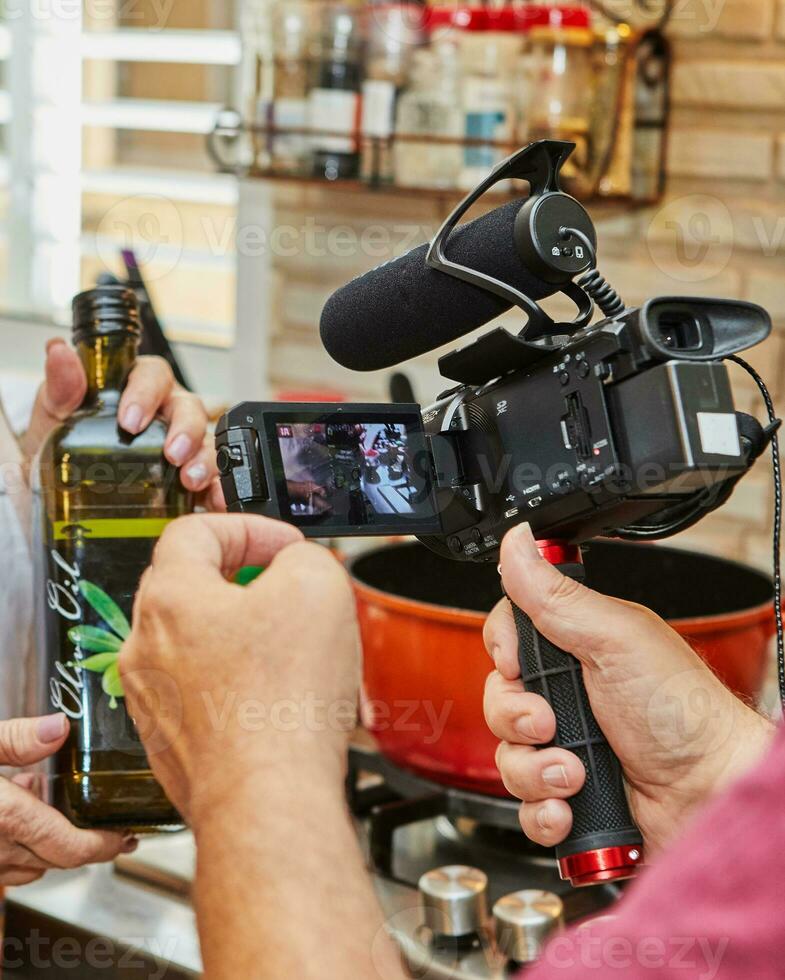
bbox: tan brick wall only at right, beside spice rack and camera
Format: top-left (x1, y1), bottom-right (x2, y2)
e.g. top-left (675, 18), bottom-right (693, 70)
top-left (644, 0), bottom-right (785, 568)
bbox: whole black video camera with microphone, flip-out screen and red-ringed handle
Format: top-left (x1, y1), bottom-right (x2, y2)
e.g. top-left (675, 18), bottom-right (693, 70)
top-left (216, 141), bottom-right (781, 885)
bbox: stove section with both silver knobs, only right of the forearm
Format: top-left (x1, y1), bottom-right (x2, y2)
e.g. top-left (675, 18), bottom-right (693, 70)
top-left (347, 748), bottom-right (623, 980)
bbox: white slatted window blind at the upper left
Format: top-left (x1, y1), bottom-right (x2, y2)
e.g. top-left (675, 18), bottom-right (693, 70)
top-left (0, 0), bottom-right (241, 346)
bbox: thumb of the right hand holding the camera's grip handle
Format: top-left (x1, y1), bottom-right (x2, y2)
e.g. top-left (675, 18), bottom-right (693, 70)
top-left (501, 524), bottom-right (650, 664)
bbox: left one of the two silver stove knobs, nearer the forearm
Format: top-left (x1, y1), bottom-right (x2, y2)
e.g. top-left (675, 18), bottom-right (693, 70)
top-left (419, 864), bottom-right (488, 937)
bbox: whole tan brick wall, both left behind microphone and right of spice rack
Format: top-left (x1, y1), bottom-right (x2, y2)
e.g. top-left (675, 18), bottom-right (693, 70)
top-left (264, 0), bottom-right (785, 567)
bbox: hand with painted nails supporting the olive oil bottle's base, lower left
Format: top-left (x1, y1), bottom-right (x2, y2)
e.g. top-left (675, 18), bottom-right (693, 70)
top-left (0, 715), bottom-right (137, 886)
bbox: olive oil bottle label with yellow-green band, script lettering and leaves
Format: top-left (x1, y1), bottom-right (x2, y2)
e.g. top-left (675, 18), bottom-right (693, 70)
top-left (42, 518), bottom-right (169, 756)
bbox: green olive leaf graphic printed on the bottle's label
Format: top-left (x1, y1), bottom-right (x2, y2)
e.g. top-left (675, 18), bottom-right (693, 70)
top-left (68, 579), bottom-right (131, 710)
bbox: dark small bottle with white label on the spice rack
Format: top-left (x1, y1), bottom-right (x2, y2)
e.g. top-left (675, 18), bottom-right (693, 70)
top-left (308, 5), bottom-right (363, 180)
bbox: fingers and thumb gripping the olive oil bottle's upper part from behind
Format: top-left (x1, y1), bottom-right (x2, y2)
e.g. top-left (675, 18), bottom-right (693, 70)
top-left (22, 339), bottom-right (217, 510)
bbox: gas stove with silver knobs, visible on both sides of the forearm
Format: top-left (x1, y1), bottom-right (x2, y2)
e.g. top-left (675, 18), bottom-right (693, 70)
top-left (6, 748), bottom-right (623, 980)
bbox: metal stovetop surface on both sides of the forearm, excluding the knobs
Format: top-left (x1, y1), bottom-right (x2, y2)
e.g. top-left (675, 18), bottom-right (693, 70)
top-left (4, 752), bottom-right (619, 980)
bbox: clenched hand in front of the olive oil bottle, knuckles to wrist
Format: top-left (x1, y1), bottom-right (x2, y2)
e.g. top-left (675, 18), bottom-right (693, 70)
top-left (120, 515), bottom-right (360, 830)
